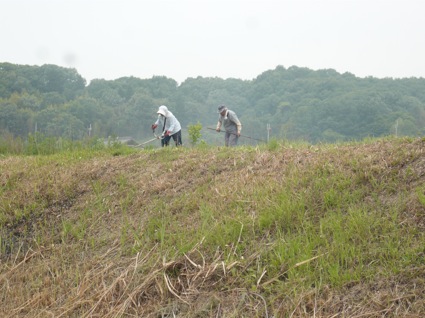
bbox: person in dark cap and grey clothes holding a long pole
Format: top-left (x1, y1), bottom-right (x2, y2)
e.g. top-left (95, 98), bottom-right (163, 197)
top-left (215, 105), bottom-right (242, 147)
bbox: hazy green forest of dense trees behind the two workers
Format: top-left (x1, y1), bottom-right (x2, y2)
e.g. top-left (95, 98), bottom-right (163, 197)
top-left (0, 63), bottom-right (425, 144)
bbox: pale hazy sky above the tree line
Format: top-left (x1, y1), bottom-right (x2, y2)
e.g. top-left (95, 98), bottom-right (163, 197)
top-left (0, 0), bottom-right (425, 83)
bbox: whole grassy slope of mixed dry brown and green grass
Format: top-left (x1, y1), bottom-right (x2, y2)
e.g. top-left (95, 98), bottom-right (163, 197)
top-left (0, 139), bottom-right (425, 317)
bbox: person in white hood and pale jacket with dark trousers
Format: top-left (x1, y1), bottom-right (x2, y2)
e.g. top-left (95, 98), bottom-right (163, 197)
top-left (152, 105), bottom-right (182, 147)
